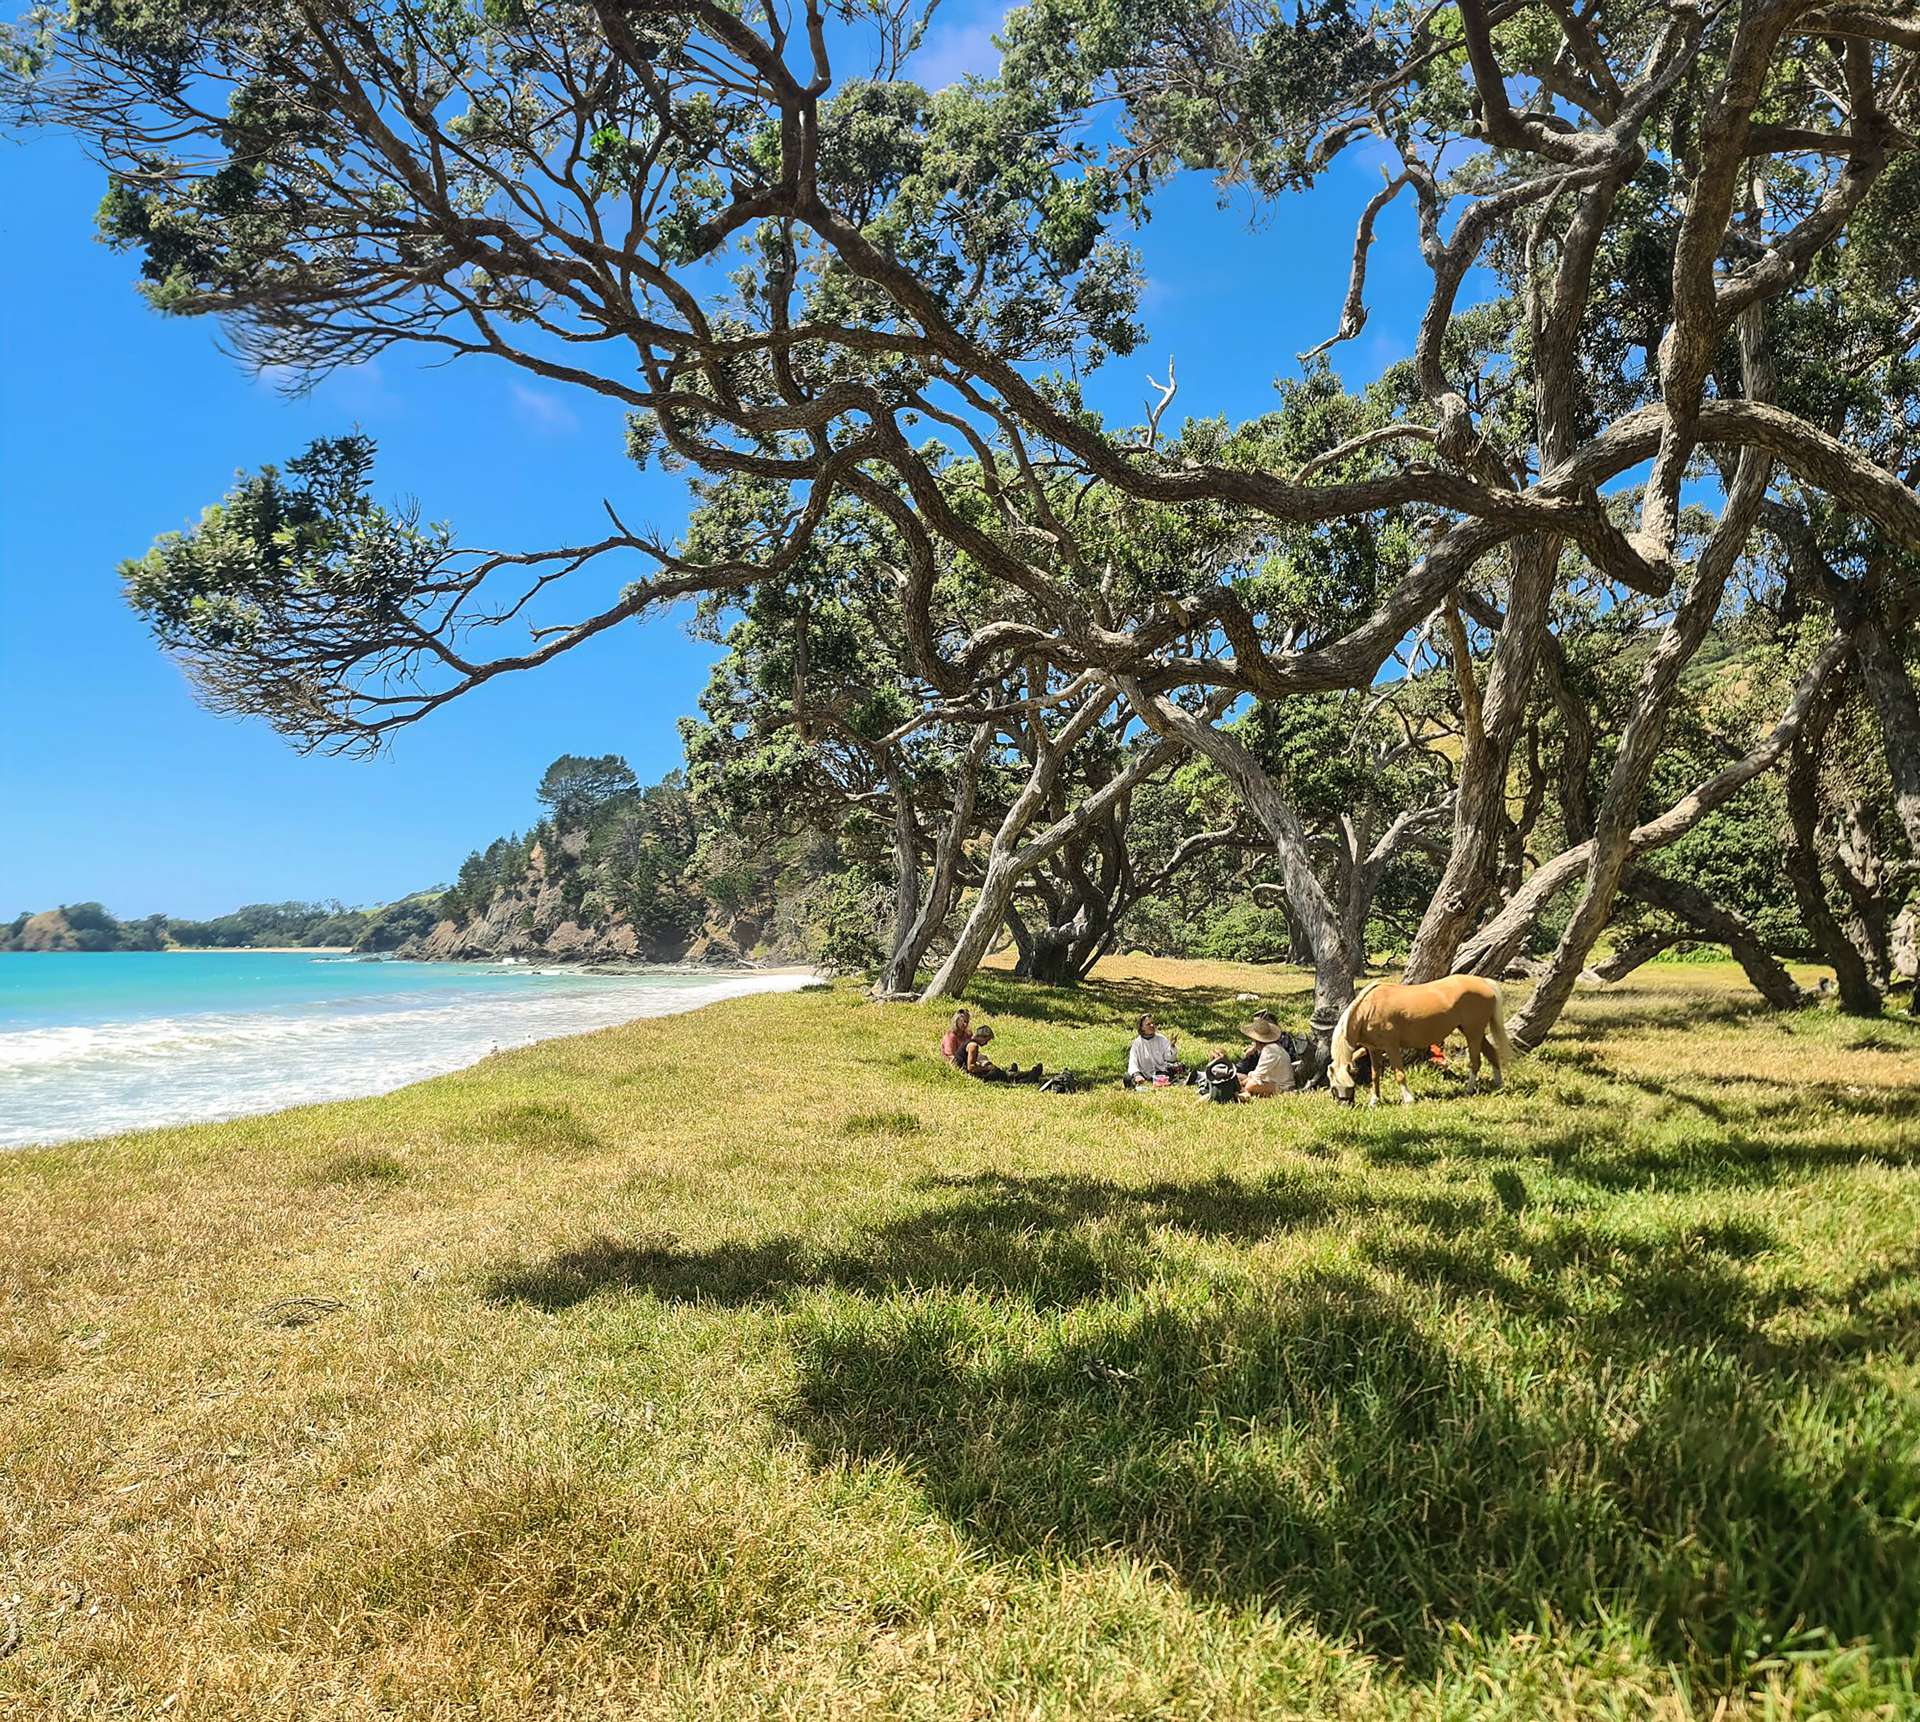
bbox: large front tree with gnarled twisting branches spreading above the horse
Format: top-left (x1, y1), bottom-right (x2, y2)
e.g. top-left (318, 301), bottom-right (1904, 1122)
top-left (10, 0), bottom-right (1920, 1037)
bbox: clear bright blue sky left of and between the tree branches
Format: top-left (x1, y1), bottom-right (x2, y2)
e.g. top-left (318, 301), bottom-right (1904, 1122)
top-left (0, 4), bottom-right (1427, 918)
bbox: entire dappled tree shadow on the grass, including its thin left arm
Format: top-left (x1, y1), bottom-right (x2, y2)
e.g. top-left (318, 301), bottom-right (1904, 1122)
top-left (488, 1173), bottom-right (1920, 1689)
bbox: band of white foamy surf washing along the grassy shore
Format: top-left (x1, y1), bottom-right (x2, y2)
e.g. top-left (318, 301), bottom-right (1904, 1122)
top-left (0, 969), bottom-right (810, 1148)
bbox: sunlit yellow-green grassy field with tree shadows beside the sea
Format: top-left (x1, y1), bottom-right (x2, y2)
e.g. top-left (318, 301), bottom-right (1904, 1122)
top-left (0, 962), bottom-right (1920, 1722)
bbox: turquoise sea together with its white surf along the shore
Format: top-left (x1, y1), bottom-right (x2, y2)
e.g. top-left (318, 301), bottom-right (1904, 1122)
top-left (0, 950), bottom-right (808, 1148)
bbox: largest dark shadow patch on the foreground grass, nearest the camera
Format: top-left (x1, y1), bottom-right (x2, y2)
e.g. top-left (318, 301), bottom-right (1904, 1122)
top-left (785, 1273), bottom-right (1920, 1684)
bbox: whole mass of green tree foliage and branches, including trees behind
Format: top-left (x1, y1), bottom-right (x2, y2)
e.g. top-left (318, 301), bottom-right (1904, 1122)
top-left (6, 0), bottom-right (1920, 1013)
